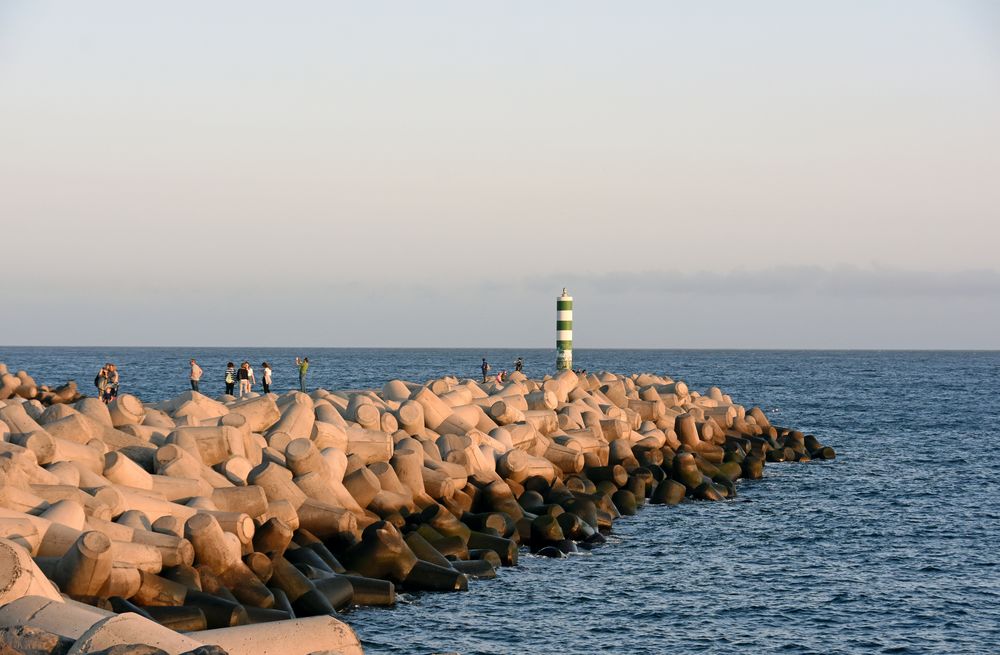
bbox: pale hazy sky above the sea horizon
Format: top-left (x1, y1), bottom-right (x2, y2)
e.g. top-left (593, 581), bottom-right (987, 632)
top-left (0, 0), bottom-right (1000, 349)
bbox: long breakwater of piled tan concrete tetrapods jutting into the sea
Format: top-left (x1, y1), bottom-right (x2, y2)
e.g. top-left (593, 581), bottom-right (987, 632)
top-left (0, 364), bottom-right (835, 655)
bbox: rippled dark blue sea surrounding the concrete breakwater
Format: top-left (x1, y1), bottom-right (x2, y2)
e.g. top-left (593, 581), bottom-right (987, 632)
top-left (0, 347), bottom-right (1000, 655)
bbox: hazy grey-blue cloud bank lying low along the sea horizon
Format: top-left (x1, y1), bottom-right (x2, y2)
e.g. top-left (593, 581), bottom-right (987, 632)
top-left (4, 267), bottom-right (1000, 349)
